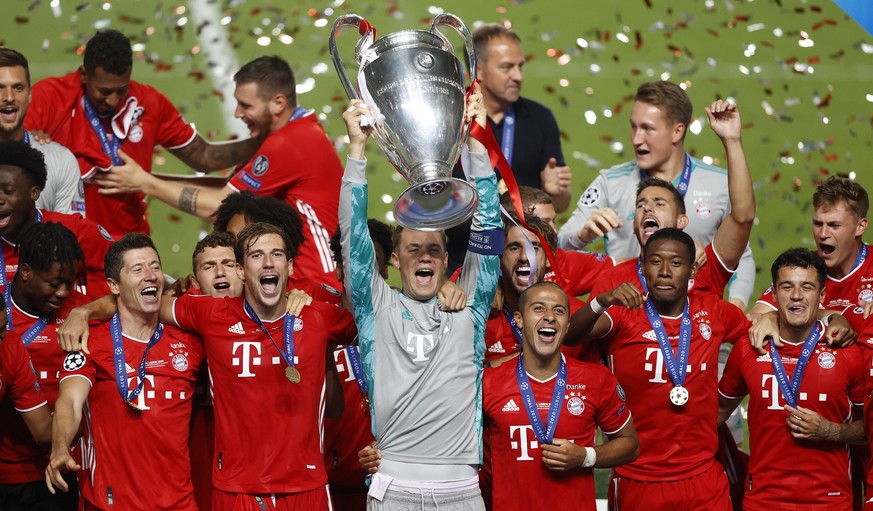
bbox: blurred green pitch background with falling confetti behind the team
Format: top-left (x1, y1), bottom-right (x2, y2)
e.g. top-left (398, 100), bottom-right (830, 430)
top-left (0, 0), bottom-right (873, 300)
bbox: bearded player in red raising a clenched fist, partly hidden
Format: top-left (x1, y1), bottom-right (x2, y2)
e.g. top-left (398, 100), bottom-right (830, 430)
top-left (592, 100), bottom-right (755, 304)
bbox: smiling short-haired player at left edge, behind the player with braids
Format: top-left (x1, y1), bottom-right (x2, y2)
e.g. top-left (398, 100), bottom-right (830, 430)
top-left (0, 141), bottom-right (112, 297)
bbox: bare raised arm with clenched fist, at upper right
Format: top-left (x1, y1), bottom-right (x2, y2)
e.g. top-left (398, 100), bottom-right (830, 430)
top-left (706, 100), bottom-right (755, 270)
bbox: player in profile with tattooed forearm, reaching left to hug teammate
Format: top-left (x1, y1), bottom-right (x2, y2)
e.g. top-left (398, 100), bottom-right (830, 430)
top-left (90, 56), bottom-right (342, 289)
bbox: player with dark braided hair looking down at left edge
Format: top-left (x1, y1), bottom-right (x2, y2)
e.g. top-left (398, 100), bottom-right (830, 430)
top-left (0, 222), bottom-right (89, 510)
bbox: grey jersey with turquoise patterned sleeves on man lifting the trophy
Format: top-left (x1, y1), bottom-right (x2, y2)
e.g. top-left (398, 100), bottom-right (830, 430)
top-left (339, 153), bottom-right (502, 465)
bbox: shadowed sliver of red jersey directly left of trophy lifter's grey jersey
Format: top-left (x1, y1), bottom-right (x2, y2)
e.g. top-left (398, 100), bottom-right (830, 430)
top-left (324, 346), bottom-right (374, 486)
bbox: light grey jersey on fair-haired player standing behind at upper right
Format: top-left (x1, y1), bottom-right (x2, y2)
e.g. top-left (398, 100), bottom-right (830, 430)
top-left (558, 158), bottom-right (755, 303)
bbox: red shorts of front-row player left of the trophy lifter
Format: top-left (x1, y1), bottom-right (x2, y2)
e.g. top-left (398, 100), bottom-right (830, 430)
top-left (212, 485), bottom-right (333, 511)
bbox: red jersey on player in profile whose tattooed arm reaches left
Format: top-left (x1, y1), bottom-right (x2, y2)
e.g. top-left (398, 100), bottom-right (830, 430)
top-left (228, 114), bottom-right (343, 289)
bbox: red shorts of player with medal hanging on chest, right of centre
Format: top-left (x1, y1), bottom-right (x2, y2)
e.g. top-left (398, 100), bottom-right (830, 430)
top-left (609, 462), bottom-right (733, 511)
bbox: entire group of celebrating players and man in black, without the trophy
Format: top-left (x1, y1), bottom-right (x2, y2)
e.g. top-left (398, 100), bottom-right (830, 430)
top-left (0, 25), bottom-right (873, 511)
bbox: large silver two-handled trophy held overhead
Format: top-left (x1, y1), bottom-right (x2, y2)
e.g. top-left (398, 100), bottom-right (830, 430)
top-left (329, 14), bottom-right (479, 231)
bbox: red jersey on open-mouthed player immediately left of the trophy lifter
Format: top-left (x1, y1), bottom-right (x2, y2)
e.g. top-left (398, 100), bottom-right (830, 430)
top-left (173, 295), bottom-right (357, 494)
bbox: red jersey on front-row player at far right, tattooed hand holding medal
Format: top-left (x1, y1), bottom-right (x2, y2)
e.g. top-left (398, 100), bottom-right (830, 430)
top-left (718, 326), bottom-right (865, 510)
